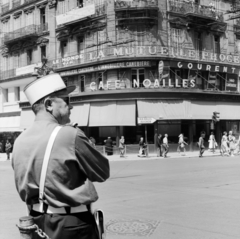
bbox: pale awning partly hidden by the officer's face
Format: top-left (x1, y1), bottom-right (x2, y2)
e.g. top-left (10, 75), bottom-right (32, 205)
top-left (70, 103), bottom-right (90, 126)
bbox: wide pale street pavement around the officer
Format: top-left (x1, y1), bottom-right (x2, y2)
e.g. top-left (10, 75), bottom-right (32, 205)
top-left (0, 152), bottom-right (240, 239)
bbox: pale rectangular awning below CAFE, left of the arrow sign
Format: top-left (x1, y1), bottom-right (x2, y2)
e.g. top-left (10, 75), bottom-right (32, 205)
top-left (89, 101), bottom-right (136, 126)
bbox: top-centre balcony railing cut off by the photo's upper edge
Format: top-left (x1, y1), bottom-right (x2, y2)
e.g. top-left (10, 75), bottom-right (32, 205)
top-left (115, 0), bottom-right (158, 11)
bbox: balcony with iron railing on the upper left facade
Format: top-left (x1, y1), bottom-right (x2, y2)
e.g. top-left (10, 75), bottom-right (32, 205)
top-left (4, 23), bottom-right (48, 44)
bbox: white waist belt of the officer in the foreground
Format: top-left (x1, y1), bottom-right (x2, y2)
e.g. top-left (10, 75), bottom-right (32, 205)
top-left (32, 203), bottom-right (88, 214)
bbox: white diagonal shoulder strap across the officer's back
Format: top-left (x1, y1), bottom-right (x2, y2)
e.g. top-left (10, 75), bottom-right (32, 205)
top-left (39, 126), bottom-right (62, 212)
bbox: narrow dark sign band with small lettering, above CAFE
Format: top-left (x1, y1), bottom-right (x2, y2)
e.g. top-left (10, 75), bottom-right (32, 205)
top-left (60, 61), bottom-right (154, 76)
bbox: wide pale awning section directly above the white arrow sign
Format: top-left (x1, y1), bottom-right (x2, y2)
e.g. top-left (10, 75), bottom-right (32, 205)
top-left (137, 100), bottom-right (191, 120)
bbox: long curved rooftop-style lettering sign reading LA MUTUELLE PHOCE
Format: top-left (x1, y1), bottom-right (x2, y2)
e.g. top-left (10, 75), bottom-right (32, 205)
top-left (52, 45), bottom-right (240, 68)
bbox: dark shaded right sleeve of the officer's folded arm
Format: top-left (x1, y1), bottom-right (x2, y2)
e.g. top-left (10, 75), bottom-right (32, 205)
top-left (75, 130), bottom-right (110, 182)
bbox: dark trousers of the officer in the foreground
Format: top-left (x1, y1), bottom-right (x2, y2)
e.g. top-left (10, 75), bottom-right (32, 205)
top-left (30, 211), bottom-right (98, 239)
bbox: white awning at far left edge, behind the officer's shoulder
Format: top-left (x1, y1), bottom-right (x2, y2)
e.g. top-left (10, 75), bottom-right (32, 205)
top-left (0, 116), bottom-right (22, 132)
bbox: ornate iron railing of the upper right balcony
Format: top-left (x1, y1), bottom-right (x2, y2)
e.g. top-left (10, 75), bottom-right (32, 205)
top-left (168, 0), bottom-right (224, 21)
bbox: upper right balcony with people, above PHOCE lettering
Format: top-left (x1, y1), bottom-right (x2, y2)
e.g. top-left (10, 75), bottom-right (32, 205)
top-left (168, 0), bottom-right (224, 22)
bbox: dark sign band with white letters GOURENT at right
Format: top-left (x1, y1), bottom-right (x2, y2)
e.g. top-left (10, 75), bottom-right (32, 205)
top-left (170, 61), bottom-right (240, 76)
